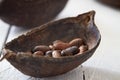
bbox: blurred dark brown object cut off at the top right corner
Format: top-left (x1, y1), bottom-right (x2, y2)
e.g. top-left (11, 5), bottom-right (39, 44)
top-left (99, 0), bottom-right (120, 8)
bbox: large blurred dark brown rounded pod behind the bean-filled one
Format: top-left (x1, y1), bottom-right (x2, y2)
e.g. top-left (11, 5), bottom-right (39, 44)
top-left (0, 0), bottom-right (68, 28)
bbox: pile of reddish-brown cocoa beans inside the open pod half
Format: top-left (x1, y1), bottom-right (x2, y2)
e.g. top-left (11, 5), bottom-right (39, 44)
top-left (32, 38), bottom-right (88, 58)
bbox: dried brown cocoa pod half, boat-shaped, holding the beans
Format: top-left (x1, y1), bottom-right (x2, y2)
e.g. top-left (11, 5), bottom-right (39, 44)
top-left (0, 11), bottom-right (101, 77)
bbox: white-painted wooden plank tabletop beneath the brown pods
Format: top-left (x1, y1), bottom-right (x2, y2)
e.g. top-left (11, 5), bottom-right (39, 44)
top-left (0, 0), bottom-right (120, 80)
